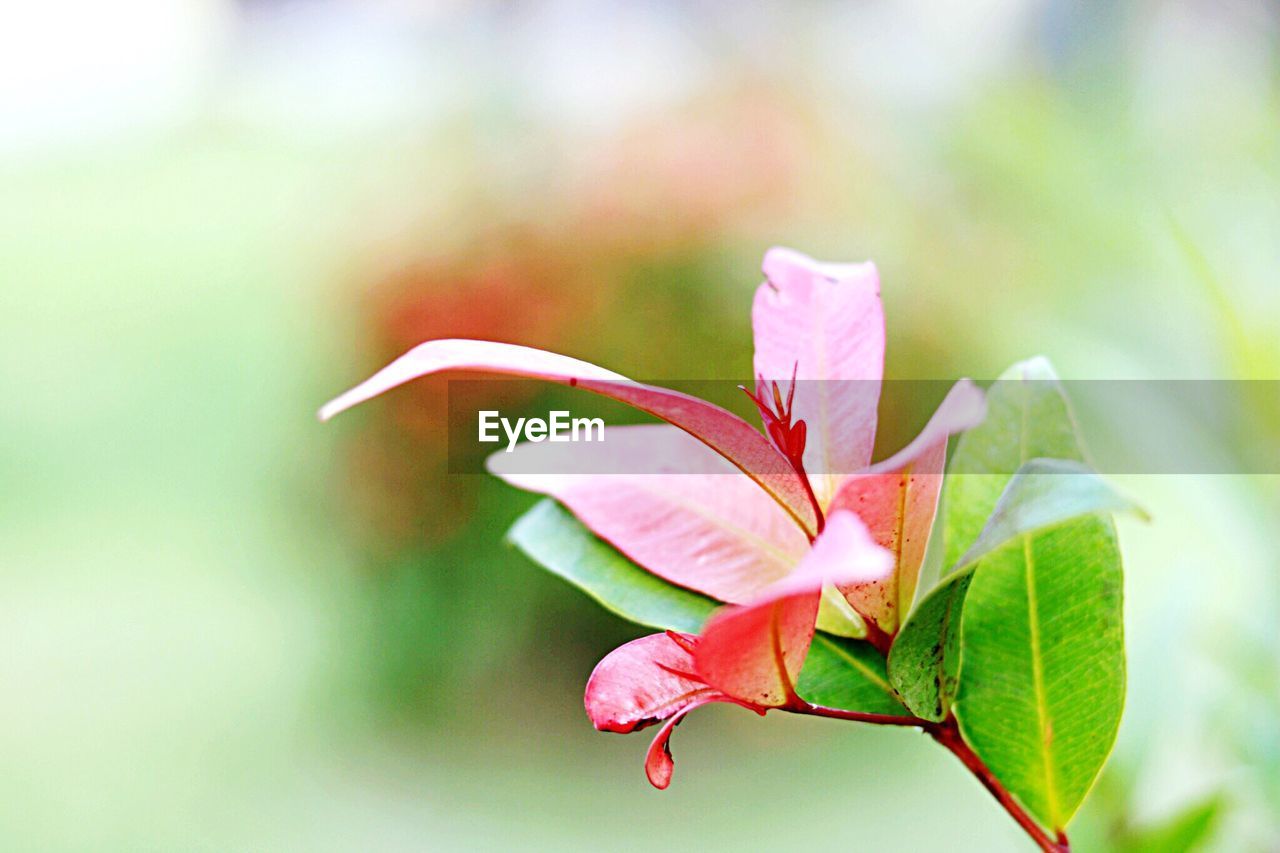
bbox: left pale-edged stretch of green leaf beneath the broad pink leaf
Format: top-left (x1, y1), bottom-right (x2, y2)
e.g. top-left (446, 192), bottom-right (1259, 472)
top-left (507, 498), bottom-right (721, 633)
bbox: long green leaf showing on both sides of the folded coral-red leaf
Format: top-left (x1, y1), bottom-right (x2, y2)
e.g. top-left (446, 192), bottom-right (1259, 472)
top-left (507, 498), bottom-right (902, 713)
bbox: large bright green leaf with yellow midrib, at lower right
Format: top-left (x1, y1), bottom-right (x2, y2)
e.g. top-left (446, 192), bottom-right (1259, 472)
top-left (955, 519), bottom-right (1125, 829)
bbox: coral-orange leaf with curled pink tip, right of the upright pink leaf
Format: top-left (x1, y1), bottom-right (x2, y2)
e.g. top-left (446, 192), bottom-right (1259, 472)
top-left (831, 380), bottom-right (987, 635)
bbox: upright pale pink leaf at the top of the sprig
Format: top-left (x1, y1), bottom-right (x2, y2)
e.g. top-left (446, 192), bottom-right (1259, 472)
top-left (751, 248), bottom-right (884, 503)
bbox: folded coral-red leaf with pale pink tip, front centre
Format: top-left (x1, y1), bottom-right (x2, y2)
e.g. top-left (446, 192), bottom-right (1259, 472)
top-left (694, 512), bottom-right (893, 707)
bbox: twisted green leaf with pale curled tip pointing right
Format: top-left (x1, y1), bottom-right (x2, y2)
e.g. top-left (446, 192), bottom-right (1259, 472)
top-left (888, 459), bottom-right (1142, 721)
